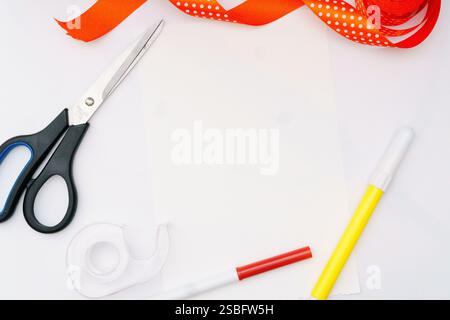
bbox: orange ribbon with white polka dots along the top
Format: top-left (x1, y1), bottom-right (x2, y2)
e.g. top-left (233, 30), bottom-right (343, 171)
top-left (57, 0), bottom-right (441, 48)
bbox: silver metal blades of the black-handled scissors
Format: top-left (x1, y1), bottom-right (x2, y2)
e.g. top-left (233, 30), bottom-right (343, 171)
top-left (69, 20), bottom-right (164, 125)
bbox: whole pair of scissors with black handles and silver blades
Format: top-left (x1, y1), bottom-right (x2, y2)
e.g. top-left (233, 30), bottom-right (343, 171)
top-left (0, 20), bottom-right (164, 234)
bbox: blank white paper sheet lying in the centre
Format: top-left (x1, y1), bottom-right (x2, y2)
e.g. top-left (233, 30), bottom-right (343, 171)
top-left (140, 10), bottom-right (359, 299)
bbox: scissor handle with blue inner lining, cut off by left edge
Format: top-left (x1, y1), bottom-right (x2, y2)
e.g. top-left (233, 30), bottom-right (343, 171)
top-left (0, 109), bottom-right (69, 223)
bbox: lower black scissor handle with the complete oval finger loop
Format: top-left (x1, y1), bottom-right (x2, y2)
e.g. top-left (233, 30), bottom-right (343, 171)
top-left (23, 123), bottom-right (89, 233)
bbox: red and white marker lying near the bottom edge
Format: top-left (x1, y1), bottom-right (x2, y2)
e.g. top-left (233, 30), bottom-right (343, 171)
top-left (158, 247), bottom-right (312, 300)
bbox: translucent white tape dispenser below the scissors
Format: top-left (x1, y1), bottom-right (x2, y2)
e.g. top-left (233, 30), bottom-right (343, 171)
top-left (66, 223), bottom-right (169, 298)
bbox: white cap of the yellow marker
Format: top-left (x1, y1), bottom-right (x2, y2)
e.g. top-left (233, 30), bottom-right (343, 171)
top-left (369, 128), bottom-right (414, 191)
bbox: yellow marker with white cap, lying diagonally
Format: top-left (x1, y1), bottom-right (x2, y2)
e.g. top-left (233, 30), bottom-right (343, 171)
top-left (311, 128), bottom-right (414, 300)
